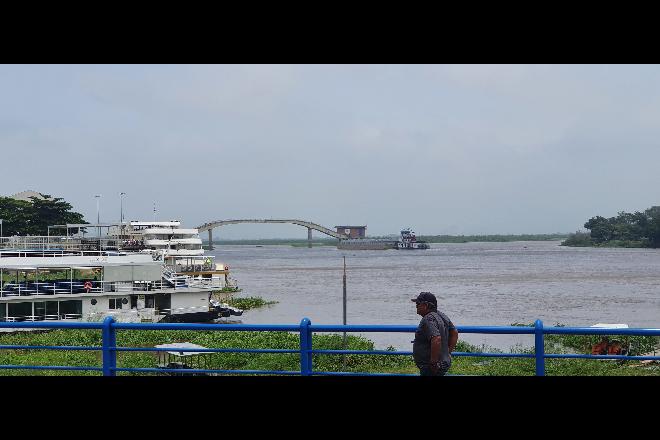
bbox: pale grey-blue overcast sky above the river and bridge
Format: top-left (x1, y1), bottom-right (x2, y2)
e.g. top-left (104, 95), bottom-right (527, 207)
top-left (0, 65), bottom-right (660, 239)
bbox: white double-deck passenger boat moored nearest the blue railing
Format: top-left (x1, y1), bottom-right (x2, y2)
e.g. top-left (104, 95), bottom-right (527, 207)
top-left (0, 249), bottom-right (241, 322)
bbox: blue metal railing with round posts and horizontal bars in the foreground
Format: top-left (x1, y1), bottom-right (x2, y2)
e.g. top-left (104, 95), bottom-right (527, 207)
top-left (0, 317), bottom-right (660, 376)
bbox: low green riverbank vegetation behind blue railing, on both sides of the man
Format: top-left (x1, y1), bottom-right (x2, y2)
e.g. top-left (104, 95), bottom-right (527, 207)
top-left (0, 324), bottom-right (660, 376)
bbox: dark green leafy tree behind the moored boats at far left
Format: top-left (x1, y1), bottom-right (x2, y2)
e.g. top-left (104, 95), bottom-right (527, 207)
top-left (0, 194), bottom-right (87, 237)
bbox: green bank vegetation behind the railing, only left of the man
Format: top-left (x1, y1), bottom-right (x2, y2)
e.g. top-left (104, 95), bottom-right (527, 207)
top-left (0, 330), bottom-right (412, 376)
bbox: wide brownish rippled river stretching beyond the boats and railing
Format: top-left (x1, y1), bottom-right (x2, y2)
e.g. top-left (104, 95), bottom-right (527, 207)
top-left (209, 241), bottom-right (660, 350)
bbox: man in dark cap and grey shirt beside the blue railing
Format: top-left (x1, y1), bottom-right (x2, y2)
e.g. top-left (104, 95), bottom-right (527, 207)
top-left (412, 292), bottom-right (458, 376)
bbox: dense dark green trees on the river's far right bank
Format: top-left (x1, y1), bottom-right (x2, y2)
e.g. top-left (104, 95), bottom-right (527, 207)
top-left (562, 206), bottom-right (660, 248)
